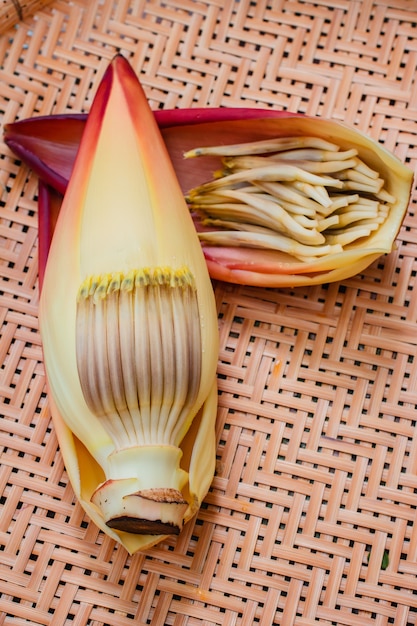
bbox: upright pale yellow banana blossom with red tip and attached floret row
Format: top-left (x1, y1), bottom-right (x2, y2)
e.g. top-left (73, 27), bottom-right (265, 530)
top-left (39, 56), bottom-right (218, 553)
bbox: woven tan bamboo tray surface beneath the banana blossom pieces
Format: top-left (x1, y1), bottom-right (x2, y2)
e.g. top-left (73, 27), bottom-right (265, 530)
top-left (0, 0), bottom-right (417, 626)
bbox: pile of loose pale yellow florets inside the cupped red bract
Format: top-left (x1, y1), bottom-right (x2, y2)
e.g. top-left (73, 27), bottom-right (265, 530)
top-left (185, 137), bottom-right (396, 262)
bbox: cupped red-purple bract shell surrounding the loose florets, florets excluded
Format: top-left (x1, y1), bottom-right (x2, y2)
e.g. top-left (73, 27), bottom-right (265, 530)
top-left (5, 85), bottom-right (413, 287)
